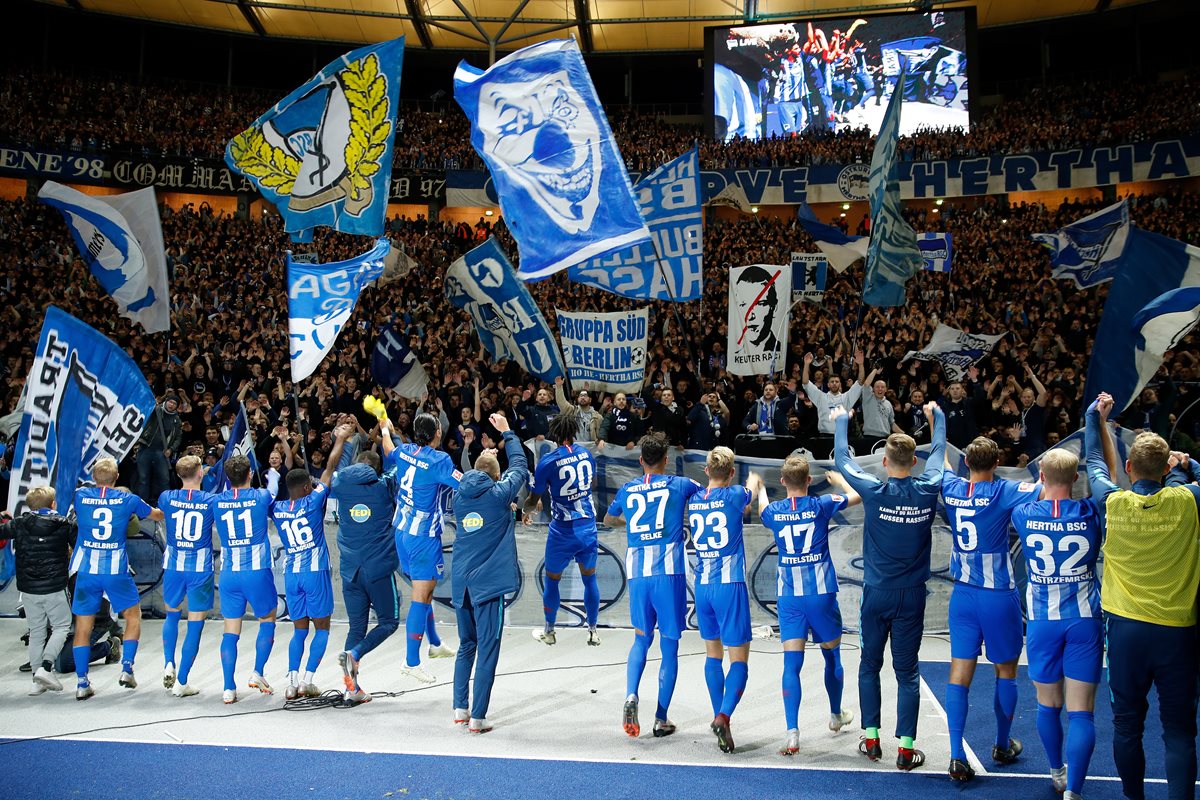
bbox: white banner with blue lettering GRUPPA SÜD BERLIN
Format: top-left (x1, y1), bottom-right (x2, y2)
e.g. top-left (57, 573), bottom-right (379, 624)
top-left (556, 308), bottom-right (649, 392)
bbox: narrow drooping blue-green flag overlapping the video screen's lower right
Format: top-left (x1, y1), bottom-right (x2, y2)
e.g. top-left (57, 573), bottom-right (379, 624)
top-left (863, 67), bottom-right (925, 307)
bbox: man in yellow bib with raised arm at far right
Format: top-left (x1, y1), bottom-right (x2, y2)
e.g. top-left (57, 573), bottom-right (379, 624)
top-left (1084, 393), bottom-right (1200, 800)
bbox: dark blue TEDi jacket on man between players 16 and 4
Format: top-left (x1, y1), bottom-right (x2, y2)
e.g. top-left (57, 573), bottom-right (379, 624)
top-left (330, 464), bottom-right (400, 582)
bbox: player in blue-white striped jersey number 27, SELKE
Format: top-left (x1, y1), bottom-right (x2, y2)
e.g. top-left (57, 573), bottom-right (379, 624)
top-left (605, 434), bottom-right (703, 736)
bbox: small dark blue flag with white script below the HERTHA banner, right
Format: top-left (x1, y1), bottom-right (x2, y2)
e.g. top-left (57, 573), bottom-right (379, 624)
top-left (1033, 200), bottom-right (1132, 287)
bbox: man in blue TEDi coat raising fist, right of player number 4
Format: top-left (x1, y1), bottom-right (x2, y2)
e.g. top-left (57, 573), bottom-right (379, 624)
top-left (450, 414), bottom-right (529, 733)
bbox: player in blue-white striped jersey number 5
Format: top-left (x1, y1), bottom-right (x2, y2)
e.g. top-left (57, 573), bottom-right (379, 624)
top-left (942, 437), bottom-right (1042, 781)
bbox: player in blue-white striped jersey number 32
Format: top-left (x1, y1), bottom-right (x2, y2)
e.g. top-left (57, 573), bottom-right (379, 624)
top-left (1013, 450), bottom-right (1104, 800)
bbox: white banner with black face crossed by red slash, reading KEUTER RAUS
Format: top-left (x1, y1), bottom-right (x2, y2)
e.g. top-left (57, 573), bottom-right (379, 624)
top-left (727, 264), bottom-right (792, 375)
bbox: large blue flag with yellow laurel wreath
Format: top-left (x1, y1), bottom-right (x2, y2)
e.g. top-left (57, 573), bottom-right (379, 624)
top-left (226, 36), bottom-right (404, 241)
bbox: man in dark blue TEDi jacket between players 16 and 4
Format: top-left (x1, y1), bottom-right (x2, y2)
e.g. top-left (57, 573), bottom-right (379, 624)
top-left (330, 451), bottom-right (400, 703)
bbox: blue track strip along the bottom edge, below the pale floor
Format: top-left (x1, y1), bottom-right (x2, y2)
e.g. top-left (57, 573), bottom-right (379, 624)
top-left (0, 730), bottom-right (1132, 800)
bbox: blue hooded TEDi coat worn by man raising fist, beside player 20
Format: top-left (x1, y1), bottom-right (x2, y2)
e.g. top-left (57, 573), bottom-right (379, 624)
top-left (450, 431), bottom-right (529, 608)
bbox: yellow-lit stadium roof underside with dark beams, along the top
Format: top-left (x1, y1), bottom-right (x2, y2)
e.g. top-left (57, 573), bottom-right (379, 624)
top-left (40, 0), bottom-right (1148, 54)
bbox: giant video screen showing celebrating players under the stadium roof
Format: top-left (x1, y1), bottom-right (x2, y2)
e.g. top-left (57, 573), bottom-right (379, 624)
top-left (706, 10), bottom-right (974, 142)
